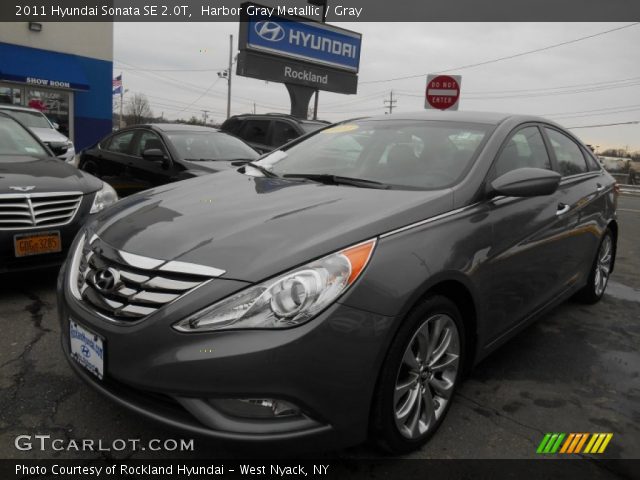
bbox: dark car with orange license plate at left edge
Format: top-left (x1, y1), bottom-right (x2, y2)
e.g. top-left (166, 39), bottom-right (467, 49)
top-left (0, 112), bottom-right (118, 273)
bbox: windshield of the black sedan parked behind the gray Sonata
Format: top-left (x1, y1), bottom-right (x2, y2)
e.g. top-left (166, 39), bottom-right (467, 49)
top-left (167, 131), bottom-right (259, 161)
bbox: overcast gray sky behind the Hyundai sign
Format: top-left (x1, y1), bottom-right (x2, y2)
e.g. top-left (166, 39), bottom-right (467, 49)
top-left (114, 22), bottom-right (640, 151)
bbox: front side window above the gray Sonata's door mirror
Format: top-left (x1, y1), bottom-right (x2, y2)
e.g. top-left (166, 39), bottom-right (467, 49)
top-left (493, 126), bottom-right (551, 178)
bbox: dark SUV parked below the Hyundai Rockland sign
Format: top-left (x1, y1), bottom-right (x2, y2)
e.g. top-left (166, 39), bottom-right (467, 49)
top-left (220, 113), bottom-right (328, 153)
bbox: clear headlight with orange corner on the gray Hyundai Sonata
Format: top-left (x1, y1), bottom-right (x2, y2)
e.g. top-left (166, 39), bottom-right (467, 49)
top-left (173, 239), bottom-right (376, 332)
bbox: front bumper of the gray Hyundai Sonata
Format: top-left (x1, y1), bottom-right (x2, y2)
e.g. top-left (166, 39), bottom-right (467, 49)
top-left (58, 262), bottom-right (393, 446)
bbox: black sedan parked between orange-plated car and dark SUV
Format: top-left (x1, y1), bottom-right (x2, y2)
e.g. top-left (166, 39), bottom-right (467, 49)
top-left (78, 123), bottom-right (259, 197)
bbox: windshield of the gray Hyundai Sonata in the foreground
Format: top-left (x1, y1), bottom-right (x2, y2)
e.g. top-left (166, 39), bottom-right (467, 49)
top-left (259, 120), bottom-right (491, 190)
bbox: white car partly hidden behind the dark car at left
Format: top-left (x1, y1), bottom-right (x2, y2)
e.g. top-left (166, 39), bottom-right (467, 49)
top-left (0, 105), bottom-right (76, 163)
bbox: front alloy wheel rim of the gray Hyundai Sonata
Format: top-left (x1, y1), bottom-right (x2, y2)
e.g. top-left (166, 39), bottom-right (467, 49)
top-left (393, 314), bottom-right (460, 439)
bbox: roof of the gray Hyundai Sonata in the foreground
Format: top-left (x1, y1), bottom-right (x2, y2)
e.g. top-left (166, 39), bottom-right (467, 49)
top-left (359, 110), bottom-right (554, 125)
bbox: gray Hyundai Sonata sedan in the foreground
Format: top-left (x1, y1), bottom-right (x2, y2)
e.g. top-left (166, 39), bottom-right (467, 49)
top-left (59, 112), bottom-right (618, 452)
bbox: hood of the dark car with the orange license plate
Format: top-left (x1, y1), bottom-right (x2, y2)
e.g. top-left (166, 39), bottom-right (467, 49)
top-left (0, 156), bottom-right (102, 194)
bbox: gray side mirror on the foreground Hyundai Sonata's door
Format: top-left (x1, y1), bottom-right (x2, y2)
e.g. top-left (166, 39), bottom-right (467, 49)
top-left (491, 168), bottom-right (562, 197)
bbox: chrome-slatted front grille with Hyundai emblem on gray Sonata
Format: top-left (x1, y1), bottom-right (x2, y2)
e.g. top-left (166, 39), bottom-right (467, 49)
top-left (71, 235), bottom-right (225, 322)
